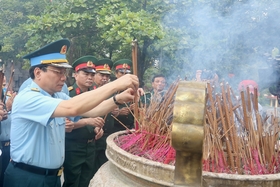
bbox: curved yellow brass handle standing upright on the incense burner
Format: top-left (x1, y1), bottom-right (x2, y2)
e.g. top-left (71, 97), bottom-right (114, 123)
top-left (172, 81), bottom-right (206, 187)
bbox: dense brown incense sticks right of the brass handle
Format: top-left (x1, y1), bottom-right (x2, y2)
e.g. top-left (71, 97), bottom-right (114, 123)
top-left (203, 83), bottom-right (280, 175)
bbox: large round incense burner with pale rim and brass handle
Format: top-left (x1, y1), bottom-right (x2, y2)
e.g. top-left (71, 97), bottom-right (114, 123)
top-left (89, 81), bottom-right (280, 187)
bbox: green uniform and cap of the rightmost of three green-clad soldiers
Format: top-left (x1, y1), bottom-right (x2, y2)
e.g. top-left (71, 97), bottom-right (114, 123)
top-left (113, 59), bottom-right (134, 132)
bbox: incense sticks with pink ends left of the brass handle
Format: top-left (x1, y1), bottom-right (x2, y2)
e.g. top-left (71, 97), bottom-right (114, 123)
top-left (115, 80), bottom-right (179, 165)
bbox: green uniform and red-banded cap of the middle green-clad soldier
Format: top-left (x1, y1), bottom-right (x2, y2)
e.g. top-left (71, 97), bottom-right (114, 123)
top-left (93, 59), bottom-right (114, 174)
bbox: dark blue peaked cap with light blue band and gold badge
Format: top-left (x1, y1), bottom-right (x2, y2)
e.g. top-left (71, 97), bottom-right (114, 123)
top-left (23, 39), bottom-right (72, 68)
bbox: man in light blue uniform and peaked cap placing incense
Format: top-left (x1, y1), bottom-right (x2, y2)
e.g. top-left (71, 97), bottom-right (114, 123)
top-left (4, 39), bottom-right (139, 187)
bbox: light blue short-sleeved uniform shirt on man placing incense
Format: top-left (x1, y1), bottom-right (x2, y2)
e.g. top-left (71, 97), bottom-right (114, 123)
top-left (11, 81), bottom-right (80, 169)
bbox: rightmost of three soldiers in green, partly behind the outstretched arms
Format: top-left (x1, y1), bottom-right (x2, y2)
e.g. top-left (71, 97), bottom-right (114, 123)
top-left (113, 59), bottom-right (134, 132)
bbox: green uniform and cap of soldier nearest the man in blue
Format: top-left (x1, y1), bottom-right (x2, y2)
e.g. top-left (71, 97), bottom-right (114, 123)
top-left (63, 56), bottom-right (97, 187)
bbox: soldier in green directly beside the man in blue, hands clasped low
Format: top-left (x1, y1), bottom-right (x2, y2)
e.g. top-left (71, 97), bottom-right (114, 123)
top-left (63, 56), bottom-right (104, 187)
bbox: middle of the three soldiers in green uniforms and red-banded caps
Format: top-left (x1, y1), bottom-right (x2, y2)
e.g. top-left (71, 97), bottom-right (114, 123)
top-left (93, 58), bottom-right (119, 174)
